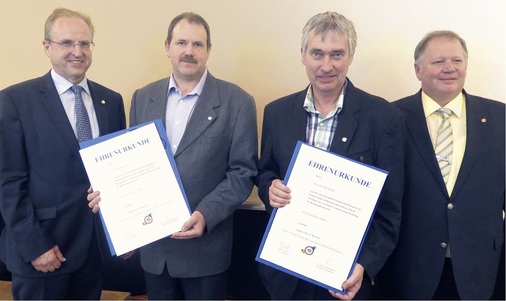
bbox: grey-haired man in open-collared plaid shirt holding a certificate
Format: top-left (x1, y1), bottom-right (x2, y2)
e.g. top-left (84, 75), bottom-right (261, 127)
top-left (256, 12), bottom-right (404, 299)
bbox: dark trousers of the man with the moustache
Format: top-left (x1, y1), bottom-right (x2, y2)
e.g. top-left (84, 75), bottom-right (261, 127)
top-left (144, 267), bottom-right (227, 300)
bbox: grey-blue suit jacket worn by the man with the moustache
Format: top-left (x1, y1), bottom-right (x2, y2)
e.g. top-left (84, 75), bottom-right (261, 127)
top-left (130, 74), bottom-right (258, 278)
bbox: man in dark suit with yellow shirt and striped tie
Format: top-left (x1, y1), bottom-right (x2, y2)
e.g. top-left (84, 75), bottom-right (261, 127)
top-left (378, 31), bottom-right (505, 300)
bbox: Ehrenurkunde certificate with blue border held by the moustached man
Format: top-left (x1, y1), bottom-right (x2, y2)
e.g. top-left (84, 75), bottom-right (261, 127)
top-left (80, 120), bottom-right (190, 255)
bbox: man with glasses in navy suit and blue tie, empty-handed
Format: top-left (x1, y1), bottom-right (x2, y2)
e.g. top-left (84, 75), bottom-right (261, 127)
top-left (0, 8), bottom-right (125, 300)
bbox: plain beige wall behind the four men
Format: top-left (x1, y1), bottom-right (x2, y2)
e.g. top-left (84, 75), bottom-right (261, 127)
top-left (0, 0), bottom-right (506, 119)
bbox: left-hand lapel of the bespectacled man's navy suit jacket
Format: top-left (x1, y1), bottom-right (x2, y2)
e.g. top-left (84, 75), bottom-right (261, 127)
top-left (40, 73), bottom-right (79, 148)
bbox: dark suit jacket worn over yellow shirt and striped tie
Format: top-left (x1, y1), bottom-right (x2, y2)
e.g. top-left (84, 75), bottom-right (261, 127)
top-left (381, 91), bottom-right (505, 299)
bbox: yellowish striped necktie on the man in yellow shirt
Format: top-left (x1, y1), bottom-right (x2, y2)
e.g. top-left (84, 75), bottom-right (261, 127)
top-left (435, 108), bottom-right (453, 183)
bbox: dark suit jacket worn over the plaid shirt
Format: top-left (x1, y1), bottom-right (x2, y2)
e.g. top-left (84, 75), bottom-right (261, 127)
top-left (255, 80), bottom-right (404, 296)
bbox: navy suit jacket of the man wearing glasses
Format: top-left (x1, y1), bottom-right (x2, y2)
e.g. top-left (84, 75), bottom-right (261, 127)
top-left (0, 73), bottom-right (125, 277)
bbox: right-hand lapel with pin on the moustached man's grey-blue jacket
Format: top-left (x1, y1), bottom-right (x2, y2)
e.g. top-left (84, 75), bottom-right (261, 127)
top-left (174, 73), bottom-right (220, 157)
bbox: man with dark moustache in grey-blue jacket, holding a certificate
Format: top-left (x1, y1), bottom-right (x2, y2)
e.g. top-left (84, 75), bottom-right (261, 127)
top-left (88, 13), bottom-right (258, 300)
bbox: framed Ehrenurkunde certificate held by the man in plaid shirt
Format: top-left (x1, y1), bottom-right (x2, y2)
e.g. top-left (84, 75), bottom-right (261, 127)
top-left (256, 142), bottom-right (387, 293)
